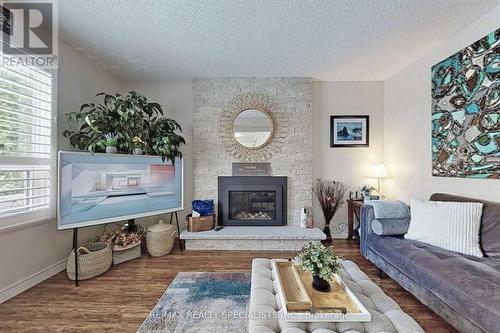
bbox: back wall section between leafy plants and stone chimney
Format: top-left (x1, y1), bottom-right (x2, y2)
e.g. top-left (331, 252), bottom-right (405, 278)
top-left (122, 81), bottom-right (193, 224)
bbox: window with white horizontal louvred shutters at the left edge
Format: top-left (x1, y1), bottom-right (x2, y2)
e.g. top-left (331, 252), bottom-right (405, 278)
top-left (0, 66), bottom-right (56, 227)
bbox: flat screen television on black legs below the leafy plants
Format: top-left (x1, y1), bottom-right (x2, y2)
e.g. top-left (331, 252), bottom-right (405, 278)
top-left (57, 151), bottom-right (184, 230)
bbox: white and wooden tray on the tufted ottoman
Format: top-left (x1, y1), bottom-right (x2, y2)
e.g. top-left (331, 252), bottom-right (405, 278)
top-left (272, 259), bottom-right (371, 322)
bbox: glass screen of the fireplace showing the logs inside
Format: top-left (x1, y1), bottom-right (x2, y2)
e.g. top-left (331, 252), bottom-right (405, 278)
top-left (229, 191), bottom-right (276, 220)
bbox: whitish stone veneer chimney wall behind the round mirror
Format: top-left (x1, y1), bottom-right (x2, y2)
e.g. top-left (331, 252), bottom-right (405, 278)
top-left (193, 78), bottom-right (312, 225)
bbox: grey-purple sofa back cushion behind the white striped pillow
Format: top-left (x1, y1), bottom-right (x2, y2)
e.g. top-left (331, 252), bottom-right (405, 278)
top-left (431, 193), bottom-right (500, 258)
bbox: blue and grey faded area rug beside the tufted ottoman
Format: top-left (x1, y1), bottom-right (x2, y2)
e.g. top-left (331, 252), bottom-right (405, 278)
top-left (137, 272), bottom-right (250, 333)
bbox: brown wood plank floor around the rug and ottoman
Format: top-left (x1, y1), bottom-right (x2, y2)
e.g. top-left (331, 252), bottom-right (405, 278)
top-left (0, 240), bottom-right (456, 333)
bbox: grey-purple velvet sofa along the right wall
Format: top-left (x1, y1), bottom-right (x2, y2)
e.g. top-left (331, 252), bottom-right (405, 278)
top-left (360, 193), bottom-right (500, 333)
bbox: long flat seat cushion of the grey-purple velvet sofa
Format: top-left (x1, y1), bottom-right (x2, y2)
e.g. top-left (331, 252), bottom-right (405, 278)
top-left (368, 234), bottom-right (500, 332)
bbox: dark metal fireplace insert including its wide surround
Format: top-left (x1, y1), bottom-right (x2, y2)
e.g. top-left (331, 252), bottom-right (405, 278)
top-left (218, 176), bottom-right (287, 226)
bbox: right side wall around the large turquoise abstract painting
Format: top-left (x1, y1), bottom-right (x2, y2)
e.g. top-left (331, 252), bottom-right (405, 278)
top-left (385, 6), bottom-right (500, 201)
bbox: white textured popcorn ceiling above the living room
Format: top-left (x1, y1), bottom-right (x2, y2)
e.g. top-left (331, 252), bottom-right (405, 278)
top-left (59, 0), bottom-right (500, 80)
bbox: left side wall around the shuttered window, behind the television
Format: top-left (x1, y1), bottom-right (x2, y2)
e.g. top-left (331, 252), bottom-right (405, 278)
top-left (0, 42), bottom-right (120, 301)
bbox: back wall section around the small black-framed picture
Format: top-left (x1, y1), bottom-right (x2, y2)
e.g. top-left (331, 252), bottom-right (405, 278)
top-left (313, 81), bottom-right (384, 237)
